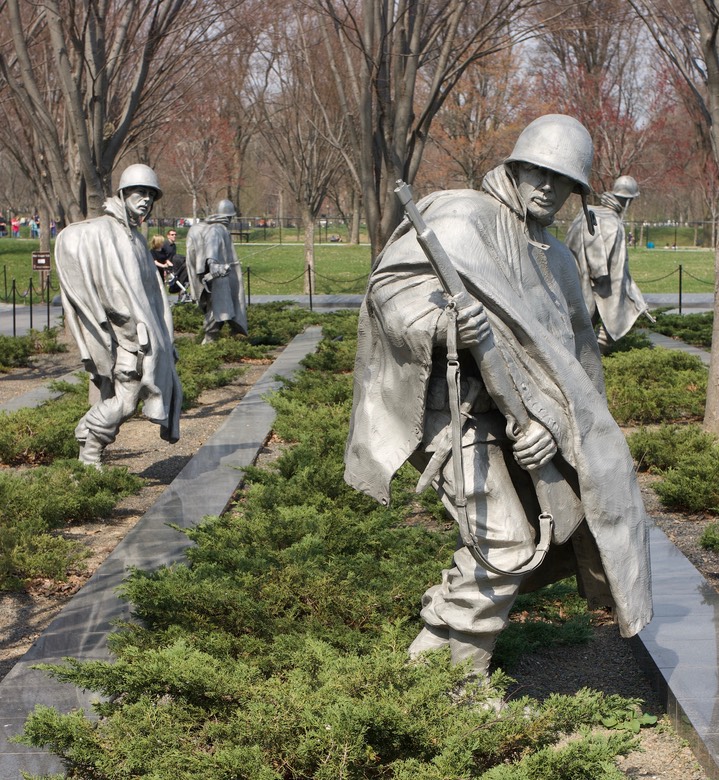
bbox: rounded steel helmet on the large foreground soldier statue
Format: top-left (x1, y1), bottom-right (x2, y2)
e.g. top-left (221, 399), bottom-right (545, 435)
top-left (505, 114), bottom-right (594, 195)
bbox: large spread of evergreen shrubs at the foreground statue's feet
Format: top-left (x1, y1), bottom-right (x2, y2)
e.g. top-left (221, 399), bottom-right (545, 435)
top-left (15, 315), bottom-right (648, 780)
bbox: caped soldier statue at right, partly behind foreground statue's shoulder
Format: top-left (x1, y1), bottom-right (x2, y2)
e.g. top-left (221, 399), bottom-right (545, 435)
top-left (566, 176), bottom-right (649, 352)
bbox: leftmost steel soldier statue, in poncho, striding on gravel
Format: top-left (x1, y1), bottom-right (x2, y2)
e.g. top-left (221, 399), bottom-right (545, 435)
top-left (55, 164), bottom-right (182, 468)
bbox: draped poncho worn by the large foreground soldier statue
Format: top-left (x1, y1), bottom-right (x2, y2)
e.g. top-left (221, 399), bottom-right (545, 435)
top-left (345, 166), bottom-right (652, 636)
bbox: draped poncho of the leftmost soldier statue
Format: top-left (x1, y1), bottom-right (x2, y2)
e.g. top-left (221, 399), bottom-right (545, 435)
top-left (55, 197), bottom-right (182, 442)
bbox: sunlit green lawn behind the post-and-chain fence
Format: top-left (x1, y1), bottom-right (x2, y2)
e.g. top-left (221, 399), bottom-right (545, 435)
top-left (0, 231), bottom-right (714, 301)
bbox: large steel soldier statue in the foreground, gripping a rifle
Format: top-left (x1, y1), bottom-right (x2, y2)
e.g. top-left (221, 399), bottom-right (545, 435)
top-left (345, 115), bottom-right (652, 675)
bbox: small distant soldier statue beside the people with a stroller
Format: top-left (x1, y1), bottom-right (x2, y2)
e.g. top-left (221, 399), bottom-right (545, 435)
top-left (187, 200), bottom-right (247, 344)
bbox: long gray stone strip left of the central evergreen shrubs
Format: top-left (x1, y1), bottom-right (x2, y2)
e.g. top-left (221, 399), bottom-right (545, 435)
top-left (0, 327), bottom-right (321, 780)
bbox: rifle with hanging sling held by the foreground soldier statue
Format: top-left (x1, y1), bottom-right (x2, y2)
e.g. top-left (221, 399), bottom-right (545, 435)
top-left (395, 179), bottom-right (584, 574)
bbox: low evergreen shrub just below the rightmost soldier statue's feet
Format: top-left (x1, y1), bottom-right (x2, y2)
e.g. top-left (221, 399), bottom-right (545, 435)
top-left (603, 348), bottom-right (707, 425)
